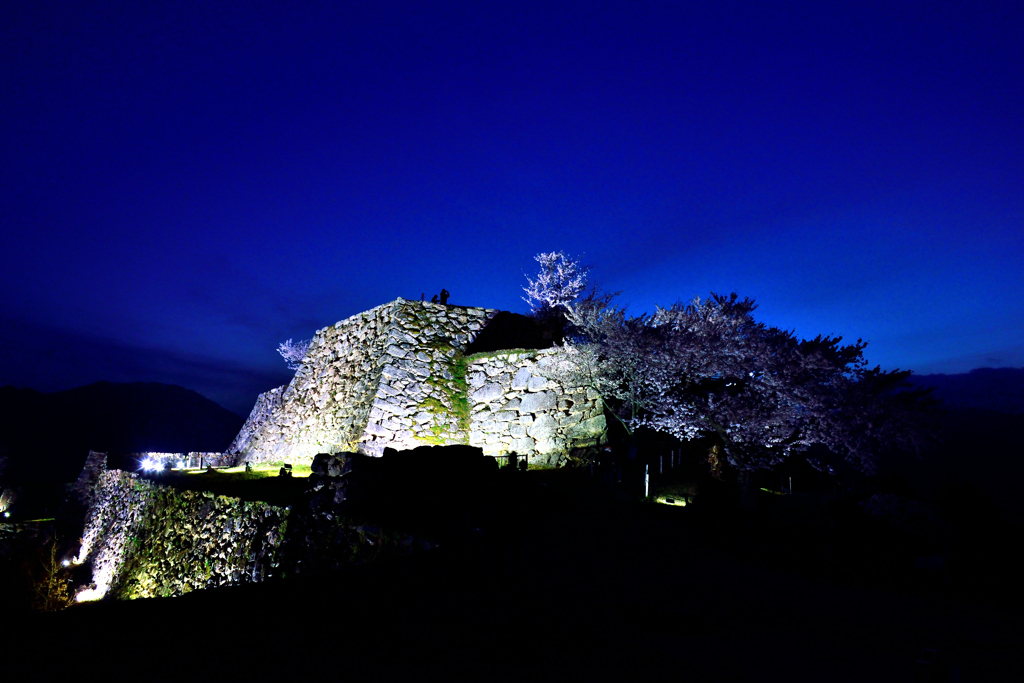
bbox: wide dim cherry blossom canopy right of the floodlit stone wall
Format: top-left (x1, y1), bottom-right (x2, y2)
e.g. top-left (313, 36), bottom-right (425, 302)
top-left (547, 286), bottom-right (928, 473)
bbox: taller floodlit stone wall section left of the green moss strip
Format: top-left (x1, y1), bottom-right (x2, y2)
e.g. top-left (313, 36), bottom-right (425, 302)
top-left (236, 299), bottom-right (496, 463)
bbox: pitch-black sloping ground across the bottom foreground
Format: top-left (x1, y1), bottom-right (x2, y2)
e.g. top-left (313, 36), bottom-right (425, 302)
top-left (0, 473), bottom-right (1024, 682)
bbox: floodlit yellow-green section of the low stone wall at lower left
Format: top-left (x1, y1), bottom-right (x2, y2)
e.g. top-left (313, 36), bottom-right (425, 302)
top-left (75, 470), bottom-right (288, 600)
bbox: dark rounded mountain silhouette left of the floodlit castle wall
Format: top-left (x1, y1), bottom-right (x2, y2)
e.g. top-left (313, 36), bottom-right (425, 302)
top-left (0, 382), bottom-right (244, 481)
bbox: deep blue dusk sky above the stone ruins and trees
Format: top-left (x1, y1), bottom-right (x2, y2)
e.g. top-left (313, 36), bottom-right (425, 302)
top-left (0, 0), bottom-right (1024, 414)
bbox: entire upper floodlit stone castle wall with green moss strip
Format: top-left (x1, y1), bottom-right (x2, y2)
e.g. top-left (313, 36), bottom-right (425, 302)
top-left (229, 299), bottom-right (605, 464)
